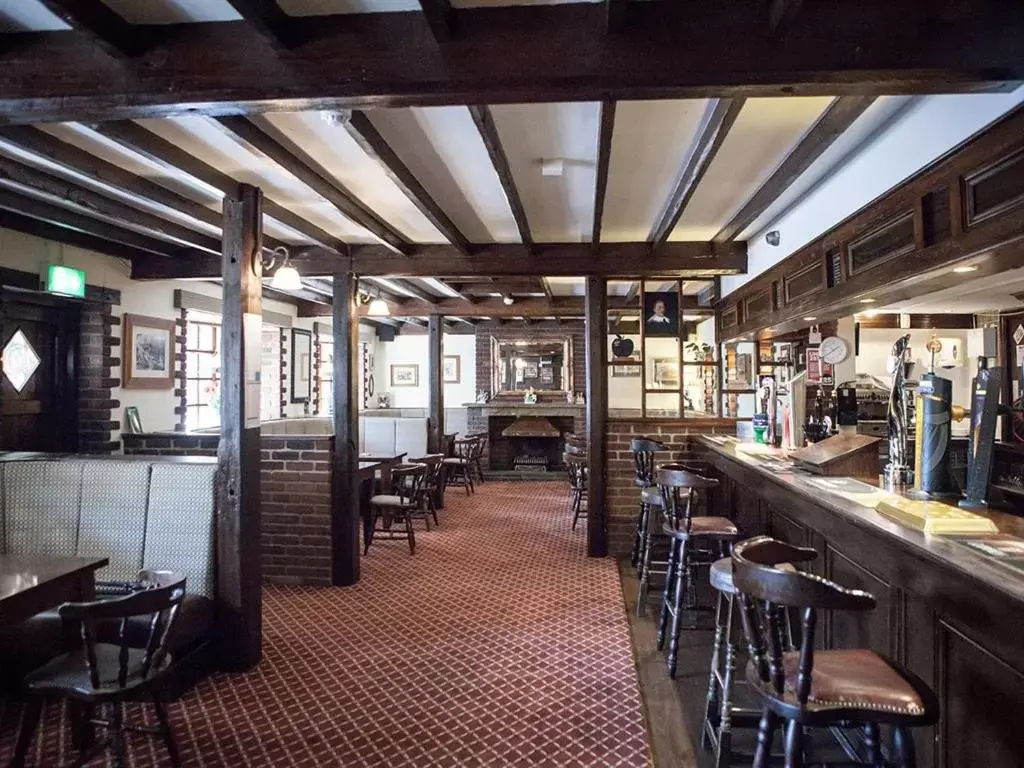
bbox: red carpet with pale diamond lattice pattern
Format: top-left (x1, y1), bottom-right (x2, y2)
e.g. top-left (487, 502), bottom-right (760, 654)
top-left (0, 482), bottom-right (650, 768)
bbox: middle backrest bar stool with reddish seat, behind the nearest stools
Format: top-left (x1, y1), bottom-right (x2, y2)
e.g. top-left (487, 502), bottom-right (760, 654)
top-left (648, 464), bottom-right (739, 678)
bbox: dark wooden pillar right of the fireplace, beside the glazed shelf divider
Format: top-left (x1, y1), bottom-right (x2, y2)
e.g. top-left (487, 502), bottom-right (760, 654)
top-left (586, 278), bottom-right (608, 557)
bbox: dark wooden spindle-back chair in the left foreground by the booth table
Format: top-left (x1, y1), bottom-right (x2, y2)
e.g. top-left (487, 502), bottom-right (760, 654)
top-left (10, 570), bottom-right (185, 768)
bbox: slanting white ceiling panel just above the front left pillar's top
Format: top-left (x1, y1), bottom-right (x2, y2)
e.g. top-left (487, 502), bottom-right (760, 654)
top-left (139, 118), bottom-right (377, 243)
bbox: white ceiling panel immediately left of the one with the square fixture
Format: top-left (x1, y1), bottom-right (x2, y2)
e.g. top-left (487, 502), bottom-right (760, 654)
top-left (367, 106), bottom-right (519, 243)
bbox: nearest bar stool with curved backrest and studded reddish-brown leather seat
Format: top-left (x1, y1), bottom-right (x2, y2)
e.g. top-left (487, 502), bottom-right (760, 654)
top-left (732, 537), bottom-right (939, 768)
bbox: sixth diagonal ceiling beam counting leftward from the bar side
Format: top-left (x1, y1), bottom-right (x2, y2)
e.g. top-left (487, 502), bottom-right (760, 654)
top-left (218, 117), bottom-right (411, 253)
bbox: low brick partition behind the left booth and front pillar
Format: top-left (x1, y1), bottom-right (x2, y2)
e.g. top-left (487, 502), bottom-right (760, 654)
top-left (124, 433), bottom-right (334, 586)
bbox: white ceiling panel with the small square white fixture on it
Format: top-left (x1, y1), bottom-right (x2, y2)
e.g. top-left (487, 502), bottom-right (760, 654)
top-left (492, 102), bottom-right (601, 243)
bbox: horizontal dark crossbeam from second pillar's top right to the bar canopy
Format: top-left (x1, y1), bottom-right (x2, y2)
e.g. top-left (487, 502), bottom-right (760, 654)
top-left (351, 242), bottom-right (746, 279)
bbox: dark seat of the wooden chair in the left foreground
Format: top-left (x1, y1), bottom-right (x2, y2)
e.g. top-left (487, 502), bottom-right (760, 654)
top-left (25, 643), bottom-right (170, 698)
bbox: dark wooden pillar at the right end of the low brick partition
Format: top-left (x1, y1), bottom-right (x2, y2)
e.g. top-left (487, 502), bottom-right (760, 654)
top-left (331, 270), bottom-right (360, 587)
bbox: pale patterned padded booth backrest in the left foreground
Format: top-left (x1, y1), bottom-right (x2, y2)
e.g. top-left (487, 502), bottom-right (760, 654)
top-left (0, 459), bottom-right (217, 597)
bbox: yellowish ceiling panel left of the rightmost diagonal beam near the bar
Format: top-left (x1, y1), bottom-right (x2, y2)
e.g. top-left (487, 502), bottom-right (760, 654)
top-left (669, 96), bottom-right (831, 240)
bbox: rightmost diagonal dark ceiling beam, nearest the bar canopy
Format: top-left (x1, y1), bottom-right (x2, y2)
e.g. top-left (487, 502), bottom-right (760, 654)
top-left (715, 96), bottom-right (874, 243)
